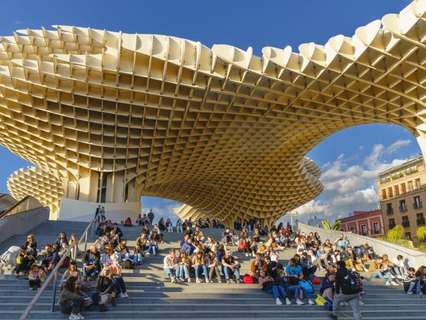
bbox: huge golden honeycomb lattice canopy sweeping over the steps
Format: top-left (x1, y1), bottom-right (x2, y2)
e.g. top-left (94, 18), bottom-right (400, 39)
top-left (0, 0), bottom-right (426, 222)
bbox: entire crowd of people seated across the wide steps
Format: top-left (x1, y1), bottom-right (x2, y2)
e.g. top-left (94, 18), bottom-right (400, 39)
top-left (5, 211), bottom-right (426, 319)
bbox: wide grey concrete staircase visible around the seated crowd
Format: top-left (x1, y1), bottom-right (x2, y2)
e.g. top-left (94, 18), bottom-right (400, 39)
top-left (0, 222), bottom-right (426, 320)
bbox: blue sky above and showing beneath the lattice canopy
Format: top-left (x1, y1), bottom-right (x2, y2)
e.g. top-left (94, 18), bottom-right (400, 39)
top-left (0, 0), bottom-right (420, 222)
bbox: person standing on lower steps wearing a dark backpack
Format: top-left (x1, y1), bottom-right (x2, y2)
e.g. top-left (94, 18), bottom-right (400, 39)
top-left (330, 261), bottom-right (362, 320)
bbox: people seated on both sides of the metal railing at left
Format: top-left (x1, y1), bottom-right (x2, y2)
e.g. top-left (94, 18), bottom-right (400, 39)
top-left (7, 219), bottom-right (166, 320)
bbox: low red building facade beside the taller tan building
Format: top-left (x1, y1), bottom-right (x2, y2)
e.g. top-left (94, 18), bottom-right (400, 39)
top-left (339, 210), bottom-right (385, 237)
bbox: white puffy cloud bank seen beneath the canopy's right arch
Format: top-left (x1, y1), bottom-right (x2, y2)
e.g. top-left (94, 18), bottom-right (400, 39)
top-left (282, 140), bottom-right (411, 222)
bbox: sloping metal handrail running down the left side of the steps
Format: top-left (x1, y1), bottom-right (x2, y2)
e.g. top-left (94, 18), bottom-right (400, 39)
top-left (19, 219), bottom-right (96, 320)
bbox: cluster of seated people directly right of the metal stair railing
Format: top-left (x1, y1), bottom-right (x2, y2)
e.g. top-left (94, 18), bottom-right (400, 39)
top-left (60, 220), bottom-right (166, 320)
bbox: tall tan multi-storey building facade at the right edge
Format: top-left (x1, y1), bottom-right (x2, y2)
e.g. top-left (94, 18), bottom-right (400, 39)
top-left (377, 156), bottom-right (426, 240)
